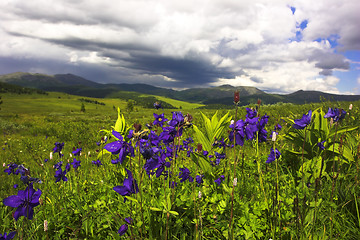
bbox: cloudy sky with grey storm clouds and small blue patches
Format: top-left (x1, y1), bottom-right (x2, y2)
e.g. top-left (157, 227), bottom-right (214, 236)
top-left (0, 0), bottom-right (360, 94)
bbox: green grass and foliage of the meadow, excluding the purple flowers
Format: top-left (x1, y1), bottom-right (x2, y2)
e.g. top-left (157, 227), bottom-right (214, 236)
top-left (0, 93), bottom-right (360, 240)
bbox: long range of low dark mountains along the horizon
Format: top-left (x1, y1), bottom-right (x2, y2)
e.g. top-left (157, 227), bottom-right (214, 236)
top-left (0, 72), bottom-right (360, 106)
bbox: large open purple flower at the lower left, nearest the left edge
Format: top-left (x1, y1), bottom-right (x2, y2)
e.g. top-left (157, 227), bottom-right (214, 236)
top-left (3, 183), bottom-right (41, 221)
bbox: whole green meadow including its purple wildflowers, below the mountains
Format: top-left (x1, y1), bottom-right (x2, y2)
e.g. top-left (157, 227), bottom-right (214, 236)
top-left (0, 93), bottom-right (360, 239)
